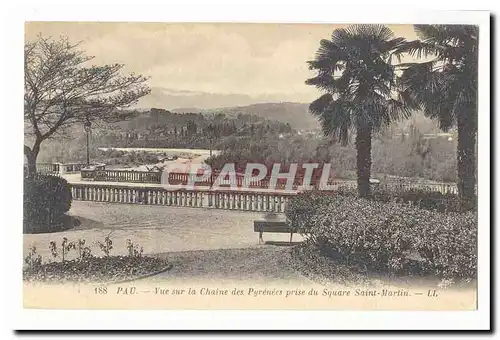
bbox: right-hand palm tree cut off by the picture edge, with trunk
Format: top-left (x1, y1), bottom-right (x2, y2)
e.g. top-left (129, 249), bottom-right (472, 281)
top-left (398, 25), bottom-right (479, 209)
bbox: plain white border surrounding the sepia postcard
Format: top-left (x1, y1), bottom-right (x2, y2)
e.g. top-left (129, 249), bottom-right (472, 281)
top-left (2, 1), bottom-right (490, 330)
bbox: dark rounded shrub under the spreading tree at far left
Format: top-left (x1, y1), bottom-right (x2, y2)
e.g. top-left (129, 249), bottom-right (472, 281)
top-left (23, 175), bottom-right (72, 232)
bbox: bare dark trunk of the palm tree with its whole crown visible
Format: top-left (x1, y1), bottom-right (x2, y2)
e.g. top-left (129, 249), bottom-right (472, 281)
top-left (356, 125), bottom-right (372, 197)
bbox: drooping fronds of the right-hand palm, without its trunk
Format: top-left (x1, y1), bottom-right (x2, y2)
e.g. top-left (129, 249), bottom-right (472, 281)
top-left (398, 25), bottom-right (479, 130)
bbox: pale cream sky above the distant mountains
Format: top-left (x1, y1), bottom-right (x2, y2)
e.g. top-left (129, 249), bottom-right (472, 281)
top-left (25, 22), bottom-right (416, 102)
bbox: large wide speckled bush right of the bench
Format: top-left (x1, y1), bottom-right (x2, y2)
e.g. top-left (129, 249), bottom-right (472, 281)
top-left (285, 193), bottom-right (477, 279)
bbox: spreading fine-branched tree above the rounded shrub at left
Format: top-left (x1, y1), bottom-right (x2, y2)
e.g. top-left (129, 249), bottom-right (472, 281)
top-left (24, 35), bottom-right (150, 176)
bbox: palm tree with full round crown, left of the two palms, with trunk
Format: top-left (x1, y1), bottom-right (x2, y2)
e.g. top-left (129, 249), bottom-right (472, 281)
top-left (306, 25), bottom-right (411, 197)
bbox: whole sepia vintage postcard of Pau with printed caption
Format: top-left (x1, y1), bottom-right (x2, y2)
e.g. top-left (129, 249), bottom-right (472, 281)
top-left (10, 3), bottom-right (489, 330)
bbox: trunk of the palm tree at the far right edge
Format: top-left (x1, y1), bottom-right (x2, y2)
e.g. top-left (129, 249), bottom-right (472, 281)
top-left (457, 113), bottom-right (476, 210)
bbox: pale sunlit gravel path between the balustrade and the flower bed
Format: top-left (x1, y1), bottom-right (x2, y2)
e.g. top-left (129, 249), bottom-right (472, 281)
top-left (24, 201), bottom-right (300, 261)
